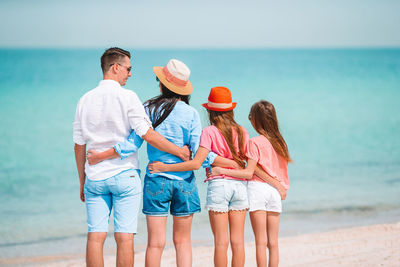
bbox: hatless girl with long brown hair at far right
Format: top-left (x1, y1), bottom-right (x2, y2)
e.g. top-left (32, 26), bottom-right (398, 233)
top-left (212, 100), bottom-right (292, 267)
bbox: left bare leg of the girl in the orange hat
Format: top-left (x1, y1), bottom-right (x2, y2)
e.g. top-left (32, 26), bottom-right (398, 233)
top-left (208, 211), bottom-right (229, 267)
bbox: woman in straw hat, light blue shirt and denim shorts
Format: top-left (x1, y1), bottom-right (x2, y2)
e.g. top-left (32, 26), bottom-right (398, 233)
top-left (87, 59), bottom-right (232, 266)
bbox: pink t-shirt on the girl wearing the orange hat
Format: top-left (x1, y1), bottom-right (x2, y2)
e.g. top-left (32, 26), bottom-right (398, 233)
top-left (200, 125), bottom-right (249, 181)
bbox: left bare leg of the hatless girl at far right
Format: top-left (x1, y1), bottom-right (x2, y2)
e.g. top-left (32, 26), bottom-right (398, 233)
top-left (250, 210), bottom-right (268, 267)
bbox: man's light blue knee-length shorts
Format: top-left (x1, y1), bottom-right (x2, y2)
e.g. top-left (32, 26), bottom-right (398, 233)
top-left (84, 169), bottom-right (142, 233)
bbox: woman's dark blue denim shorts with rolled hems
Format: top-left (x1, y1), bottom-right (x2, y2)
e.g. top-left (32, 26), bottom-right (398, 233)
top-left (142, 175), bottom-right (201, 216)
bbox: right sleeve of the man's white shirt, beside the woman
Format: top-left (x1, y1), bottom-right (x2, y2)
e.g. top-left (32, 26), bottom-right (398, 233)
top-left (127, 92), bottom-right (152, 137)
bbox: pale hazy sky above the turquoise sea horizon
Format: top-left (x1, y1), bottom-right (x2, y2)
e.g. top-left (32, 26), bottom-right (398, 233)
top-left (0, 0), bottom-right (400, 48)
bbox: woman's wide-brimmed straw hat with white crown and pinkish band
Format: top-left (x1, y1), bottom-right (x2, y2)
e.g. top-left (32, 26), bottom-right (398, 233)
top-left (153, 59), bottom-right (193, 95)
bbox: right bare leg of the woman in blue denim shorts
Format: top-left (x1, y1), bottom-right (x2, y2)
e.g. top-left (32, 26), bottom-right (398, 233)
top-left (173, 215), bottom-right (193, 267)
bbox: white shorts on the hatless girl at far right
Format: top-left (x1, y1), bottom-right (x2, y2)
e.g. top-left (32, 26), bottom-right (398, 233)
top-left (247, 181), bottom-right (282, 213)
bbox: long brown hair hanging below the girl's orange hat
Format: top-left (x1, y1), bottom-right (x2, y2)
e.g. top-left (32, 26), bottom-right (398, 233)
top-left (207, 109), bottom-right (247, 167)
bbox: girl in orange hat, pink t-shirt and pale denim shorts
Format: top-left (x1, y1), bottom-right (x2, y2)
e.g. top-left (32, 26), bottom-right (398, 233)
top-left (149, 87), bottom-right (276, 266)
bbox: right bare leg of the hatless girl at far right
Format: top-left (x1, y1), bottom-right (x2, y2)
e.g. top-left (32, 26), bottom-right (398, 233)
top-left (267, 212), bottom-right (280, 267)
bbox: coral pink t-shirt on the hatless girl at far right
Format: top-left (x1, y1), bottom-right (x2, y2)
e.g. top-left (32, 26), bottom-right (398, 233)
top-left (246, 135), bottom-right (289, 189)
